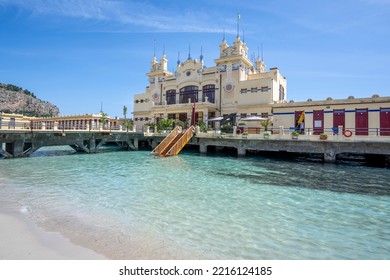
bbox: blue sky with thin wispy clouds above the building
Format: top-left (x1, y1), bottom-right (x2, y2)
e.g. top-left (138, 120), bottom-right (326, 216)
top-left (0, 0), bottom-right (390, 117)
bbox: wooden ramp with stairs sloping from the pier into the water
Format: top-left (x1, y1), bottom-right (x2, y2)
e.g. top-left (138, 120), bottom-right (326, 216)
top-left (152, 126), bottom-right (195, 157)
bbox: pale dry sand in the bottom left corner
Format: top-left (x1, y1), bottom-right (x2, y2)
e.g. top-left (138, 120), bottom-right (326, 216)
top-left (0, 208), bottom-right (107, 260)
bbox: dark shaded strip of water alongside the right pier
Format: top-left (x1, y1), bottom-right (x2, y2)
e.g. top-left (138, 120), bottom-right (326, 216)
top-left (185, 151), bottom-right (390, 196)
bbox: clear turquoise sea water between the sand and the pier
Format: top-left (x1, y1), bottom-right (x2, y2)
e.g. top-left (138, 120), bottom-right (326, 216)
top-left (0, 148), bottom-right (390, 259)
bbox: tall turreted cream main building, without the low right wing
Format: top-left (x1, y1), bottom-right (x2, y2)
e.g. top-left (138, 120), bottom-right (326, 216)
top-left (133, 36), bottom-right (287, 131)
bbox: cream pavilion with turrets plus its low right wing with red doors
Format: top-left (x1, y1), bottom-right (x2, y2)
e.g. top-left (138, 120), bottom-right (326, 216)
top-left (133, 36), bottom-right (390, 138)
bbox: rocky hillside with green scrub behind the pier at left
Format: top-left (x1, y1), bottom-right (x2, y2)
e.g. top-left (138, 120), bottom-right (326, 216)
top-left (0, 83), bottom-right (60, 117)
